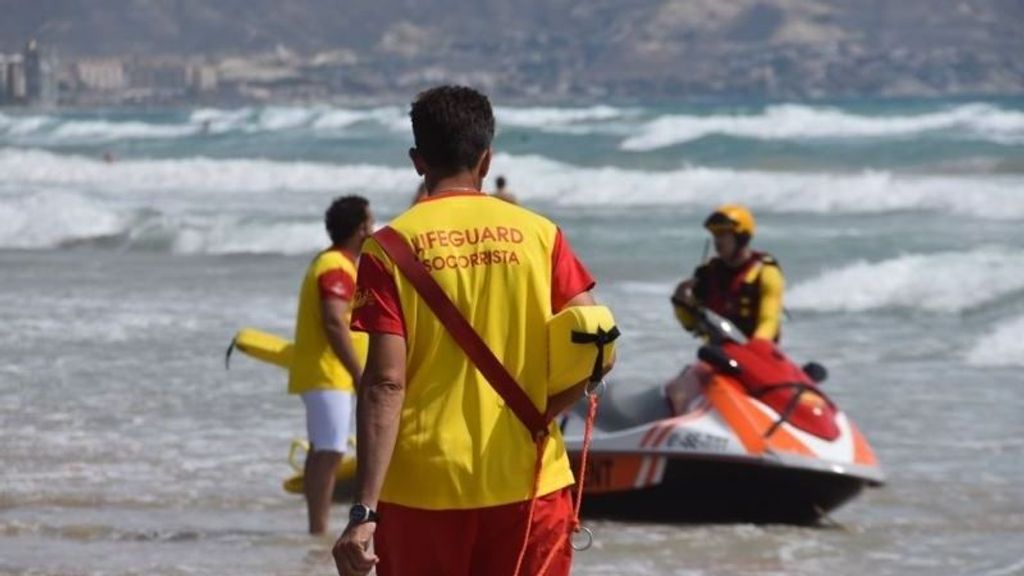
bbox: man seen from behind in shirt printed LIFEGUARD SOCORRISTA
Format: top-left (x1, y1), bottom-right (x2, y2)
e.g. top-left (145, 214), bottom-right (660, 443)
top-left (334, 86), bottom-right (610, 576)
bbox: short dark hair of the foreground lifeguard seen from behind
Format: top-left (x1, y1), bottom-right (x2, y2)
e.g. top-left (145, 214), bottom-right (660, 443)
top-left (409, 85), bottom-right (495, 175)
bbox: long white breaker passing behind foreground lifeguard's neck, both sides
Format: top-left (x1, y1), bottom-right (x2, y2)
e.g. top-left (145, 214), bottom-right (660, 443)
top-left (6, 149), bottom-right (1024, 250)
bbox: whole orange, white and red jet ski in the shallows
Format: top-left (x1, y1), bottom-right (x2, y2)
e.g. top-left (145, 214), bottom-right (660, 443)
top-left (561, 308), bottom-right (885, 524)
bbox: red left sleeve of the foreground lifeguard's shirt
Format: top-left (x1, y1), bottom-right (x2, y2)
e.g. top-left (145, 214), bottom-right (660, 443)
top-left (351, 253), bottom-right (406, 336)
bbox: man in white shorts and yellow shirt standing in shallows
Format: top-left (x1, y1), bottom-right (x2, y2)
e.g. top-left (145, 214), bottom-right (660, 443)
top-left (288, 196), bottom-right (374, 534)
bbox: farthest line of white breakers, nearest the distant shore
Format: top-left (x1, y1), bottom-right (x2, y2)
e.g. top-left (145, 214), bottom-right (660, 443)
top-left (0, 102), bottom-right (1024, 146)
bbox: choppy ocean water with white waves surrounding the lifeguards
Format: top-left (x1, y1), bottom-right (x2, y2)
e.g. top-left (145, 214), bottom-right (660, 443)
top-left (0, 100), bottom-right (1024, 576)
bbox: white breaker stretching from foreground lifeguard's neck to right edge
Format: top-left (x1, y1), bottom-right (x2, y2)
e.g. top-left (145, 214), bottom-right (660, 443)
top-left (494, 156), bottom-right (1024, 219)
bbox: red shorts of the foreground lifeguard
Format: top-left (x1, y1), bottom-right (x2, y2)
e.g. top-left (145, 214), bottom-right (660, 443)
top-left (374, 487), bottom-right (572, 576)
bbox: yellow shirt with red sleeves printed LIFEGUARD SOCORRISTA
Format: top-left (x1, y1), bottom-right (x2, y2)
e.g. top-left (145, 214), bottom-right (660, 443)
top-left (352, 193), bottom-right (594, 509)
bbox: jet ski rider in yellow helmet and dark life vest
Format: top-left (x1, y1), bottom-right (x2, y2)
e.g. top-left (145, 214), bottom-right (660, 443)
top-left (665, 204), bottom-right (785, 414)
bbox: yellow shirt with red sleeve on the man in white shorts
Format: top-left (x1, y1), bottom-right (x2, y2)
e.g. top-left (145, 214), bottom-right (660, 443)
top-left (288, 248), bottom-right (366, 394)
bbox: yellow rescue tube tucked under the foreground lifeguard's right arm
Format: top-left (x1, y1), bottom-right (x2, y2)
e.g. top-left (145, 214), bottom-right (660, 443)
top-left (548, 305), bottom-right (618, 395)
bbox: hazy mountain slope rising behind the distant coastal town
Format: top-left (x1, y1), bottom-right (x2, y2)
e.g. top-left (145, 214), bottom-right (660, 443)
top-left (0, 0), bottom-right (1024, 99)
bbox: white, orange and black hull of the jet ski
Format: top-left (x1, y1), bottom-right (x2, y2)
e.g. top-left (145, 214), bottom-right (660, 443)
top-left (563, 376), bottom-right (885, 524)
